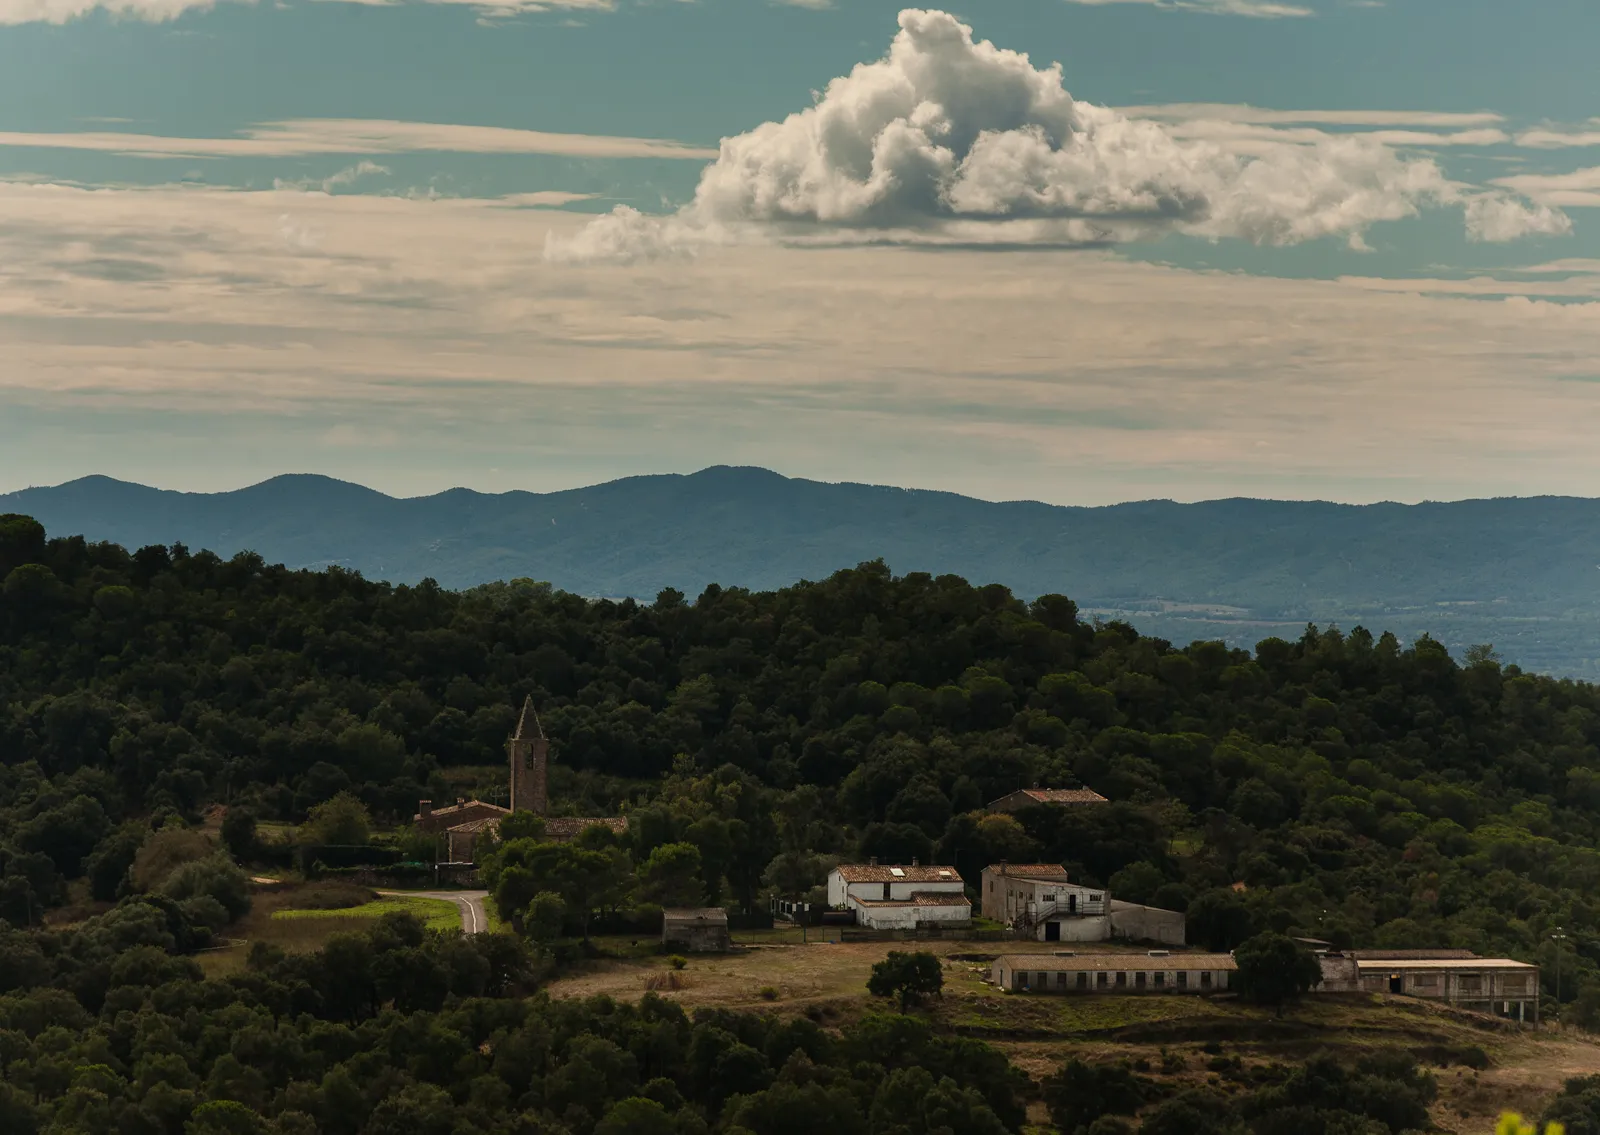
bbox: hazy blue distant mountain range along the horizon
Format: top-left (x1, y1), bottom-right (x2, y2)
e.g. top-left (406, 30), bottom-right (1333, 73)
top-left (0, 466), bottom-right (1600, 677)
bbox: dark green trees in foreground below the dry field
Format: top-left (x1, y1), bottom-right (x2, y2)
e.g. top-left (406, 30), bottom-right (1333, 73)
top-left (0, 898), bottom-right (1465, 1135)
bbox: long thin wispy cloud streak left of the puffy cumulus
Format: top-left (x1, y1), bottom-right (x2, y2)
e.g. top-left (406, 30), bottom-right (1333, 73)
top-left (0, 118), bottom-right (717, 160)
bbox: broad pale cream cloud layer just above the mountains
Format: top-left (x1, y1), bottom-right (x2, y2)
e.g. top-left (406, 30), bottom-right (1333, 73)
top-left (0, 182), bottom-right (1600, 503)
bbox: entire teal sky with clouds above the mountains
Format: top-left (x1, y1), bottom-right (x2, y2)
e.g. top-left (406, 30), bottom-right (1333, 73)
top-left (0, 0), bottom-right (1600, 504)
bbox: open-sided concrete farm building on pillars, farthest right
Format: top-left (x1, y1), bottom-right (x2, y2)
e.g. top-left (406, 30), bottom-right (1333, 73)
top-left (1317, 949), bottom-right (1539, 1025)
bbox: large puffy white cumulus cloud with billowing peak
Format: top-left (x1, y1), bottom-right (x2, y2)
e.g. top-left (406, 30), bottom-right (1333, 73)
top-left (547, 8), bottom-right (1571, 261)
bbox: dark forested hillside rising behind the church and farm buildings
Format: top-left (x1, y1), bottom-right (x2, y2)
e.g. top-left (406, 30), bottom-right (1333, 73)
top-left (0, 517), bottom-right (1600, 1015)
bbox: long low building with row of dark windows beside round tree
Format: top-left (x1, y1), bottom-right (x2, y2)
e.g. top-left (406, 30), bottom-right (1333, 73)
top-left (989, 949), bottom-right (1238, 993)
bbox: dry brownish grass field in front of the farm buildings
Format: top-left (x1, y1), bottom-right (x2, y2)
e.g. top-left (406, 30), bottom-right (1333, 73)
top-left (550, 935), bottom-right (1600, 1135)
